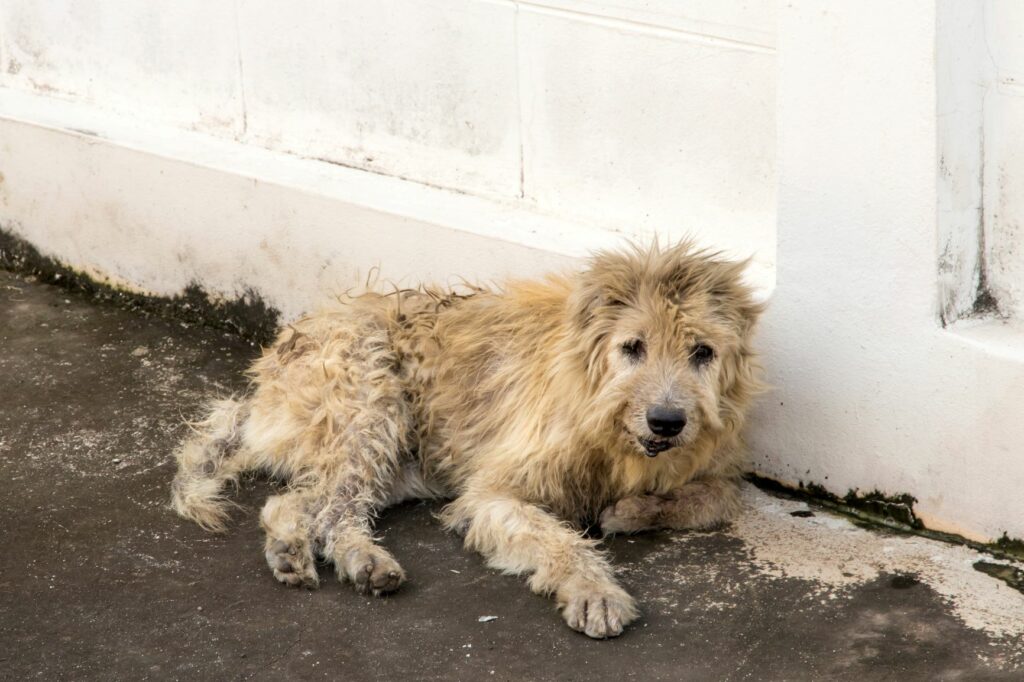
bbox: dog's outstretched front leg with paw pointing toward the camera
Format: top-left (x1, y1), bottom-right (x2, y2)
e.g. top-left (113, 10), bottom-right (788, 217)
top-left (443, 491), bottom-right (639, 639)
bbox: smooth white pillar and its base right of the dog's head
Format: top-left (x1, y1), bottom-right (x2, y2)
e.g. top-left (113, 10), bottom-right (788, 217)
top-left (751, 0), bottom-right (1024, 540)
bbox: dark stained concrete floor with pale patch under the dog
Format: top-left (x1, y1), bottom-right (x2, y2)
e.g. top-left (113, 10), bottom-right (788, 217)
top-left (0, 271), bottom-right (1024, 680)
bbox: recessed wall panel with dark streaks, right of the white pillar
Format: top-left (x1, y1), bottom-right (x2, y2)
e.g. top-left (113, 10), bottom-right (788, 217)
top-left (936, 0), bottom-right (1024, 323)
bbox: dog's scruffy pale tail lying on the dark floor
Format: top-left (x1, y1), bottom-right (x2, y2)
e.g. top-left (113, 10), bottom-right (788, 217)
top-left (171, 397), bottom-right (248, 531)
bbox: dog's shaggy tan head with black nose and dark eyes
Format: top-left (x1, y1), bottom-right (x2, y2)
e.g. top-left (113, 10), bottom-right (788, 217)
top-left (570, 244), bottom-right (762, 457)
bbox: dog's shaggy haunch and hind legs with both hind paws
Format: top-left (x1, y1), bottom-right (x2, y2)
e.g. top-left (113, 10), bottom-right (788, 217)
top-left (246, 310), bottom-right (414, 594)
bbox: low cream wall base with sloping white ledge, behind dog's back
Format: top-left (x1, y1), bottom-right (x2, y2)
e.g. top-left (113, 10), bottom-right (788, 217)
top-left (0, 93), bottom-right (593, 319)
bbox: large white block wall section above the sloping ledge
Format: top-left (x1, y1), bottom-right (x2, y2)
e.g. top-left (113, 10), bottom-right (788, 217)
top-left (0, 0), bottom-right (775, 269)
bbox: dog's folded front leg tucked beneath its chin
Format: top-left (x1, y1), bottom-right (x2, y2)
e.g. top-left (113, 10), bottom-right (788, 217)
top-left (601, 478), bottom-right (741, 536)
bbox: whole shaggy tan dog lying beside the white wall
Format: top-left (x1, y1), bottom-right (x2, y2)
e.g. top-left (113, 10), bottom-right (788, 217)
top-left (173, 244), bottom-right (761, 638)
